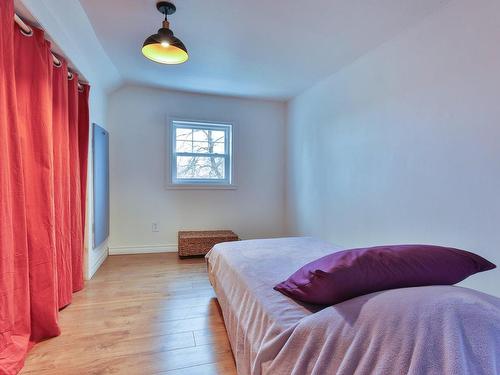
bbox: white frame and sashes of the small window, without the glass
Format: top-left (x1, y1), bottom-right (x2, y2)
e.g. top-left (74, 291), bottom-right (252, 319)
top-left (167, 118), bottom-right (236, 189)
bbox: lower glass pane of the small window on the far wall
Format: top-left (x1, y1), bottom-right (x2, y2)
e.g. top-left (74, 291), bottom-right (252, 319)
top-left (177, 156), bottom-right (225, 180)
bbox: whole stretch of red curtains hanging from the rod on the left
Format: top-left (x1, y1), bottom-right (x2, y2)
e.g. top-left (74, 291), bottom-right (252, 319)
top-left (0, 0), bottom-right (89, 374)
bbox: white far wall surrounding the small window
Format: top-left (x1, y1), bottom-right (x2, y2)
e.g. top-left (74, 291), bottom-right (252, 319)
top-left (108, 86), bottom-right (285, 253)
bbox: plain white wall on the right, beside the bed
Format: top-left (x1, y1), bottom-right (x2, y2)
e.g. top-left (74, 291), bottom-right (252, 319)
top-left (287, 0), bottom-right (500, 295)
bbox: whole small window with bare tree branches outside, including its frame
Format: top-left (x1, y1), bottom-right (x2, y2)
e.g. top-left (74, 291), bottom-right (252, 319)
top-left (170, 120), bottom-right (232, 185)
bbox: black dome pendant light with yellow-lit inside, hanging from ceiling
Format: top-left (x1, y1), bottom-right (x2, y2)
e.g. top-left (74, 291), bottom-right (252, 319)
top-left (142, 1), bottom-right (189, 65)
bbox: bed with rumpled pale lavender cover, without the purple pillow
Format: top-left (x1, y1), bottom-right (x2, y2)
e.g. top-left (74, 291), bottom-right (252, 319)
top-left (206, 238), bottom-right (500, 375)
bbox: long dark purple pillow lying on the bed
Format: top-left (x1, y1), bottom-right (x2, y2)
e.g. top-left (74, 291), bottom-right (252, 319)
top-left (274, 245), bottom-right (496, 305)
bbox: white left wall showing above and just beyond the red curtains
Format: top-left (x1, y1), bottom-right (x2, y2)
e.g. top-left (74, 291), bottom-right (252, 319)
top-left (15, 0), bottom-right (121, 279)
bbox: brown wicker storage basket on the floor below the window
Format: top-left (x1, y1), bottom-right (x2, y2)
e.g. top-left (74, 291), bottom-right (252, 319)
top-left (178, 230), bottom-right (238, 257)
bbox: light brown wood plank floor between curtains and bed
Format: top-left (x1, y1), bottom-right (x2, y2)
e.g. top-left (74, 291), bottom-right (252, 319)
top-left (21, 254), bottom-right (236, 375)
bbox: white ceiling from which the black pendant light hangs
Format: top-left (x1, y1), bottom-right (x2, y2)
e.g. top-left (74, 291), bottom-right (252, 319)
top-left (23, 0), bottom-right (450, 100)
